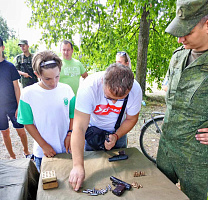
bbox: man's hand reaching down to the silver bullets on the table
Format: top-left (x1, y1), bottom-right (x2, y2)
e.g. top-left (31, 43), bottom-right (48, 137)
top-left (69, 165), bottom-right (85, 191)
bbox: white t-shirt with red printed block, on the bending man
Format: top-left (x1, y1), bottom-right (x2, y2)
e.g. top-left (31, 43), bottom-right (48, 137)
top-left (75, 72), bottom-right (142, 131)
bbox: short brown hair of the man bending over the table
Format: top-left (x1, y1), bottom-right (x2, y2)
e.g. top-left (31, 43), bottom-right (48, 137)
top-left (103, 63), bottom-right (134, 97)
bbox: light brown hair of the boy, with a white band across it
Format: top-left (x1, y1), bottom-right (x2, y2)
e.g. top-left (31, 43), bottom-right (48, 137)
top-left (32, 50), bottom-right (62, 75)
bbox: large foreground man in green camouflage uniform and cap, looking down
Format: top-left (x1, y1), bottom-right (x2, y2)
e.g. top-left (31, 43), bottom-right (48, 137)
top-left (157, 0), bottom-right (208, 200)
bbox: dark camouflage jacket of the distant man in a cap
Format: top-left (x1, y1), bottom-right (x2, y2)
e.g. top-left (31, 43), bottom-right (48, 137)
top-left (15, 53), bottom-right (38, 88)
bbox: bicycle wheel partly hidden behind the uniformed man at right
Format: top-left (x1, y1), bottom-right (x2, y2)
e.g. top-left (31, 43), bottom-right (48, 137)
top-left (139, 115), bottom-right (164, 163)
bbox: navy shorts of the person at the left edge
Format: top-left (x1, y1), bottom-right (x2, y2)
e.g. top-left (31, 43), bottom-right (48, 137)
top-left (0, 104), bottom-right (24, 131)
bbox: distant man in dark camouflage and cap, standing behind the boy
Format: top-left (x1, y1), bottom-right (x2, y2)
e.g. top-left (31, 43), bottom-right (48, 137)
top-left (15, 40), bottom-right (38, 88)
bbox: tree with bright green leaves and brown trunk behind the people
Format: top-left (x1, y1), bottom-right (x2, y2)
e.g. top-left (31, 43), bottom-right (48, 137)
top-left (27, 0), bottom-right (177, 95)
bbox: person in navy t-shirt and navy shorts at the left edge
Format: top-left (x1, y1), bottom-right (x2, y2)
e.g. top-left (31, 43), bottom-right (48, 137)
top-left (0, 37), bottom-right (33, 159)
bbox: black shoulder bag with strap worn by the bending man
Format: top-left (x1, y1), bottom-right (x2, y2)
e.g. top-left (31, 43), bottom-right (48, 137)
top-left (85, 95), bottom-right (129, 151)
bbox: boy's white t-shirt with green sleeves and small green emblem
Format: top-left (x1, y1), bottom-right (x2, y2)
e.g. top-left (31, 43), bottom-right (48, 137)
top-left (17, 83), bottom-right (75, 158)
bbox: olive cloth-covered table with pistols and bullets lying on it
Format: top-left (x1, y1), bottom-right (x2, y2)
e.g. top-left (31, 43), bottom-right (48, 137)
top-left (37, 148), bottom-right (188, 200)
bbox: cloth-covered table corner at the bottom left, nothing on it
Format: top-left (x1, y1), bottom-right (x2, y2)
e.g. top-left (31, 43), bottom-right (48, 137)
top-left (0, 158), bottom-right (39, 200)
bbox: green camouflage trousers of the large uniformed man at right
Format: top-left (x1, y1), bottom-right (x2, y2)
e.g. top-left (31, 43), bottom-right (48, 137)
top-left (157, 141), bottom-right (208, 200)
